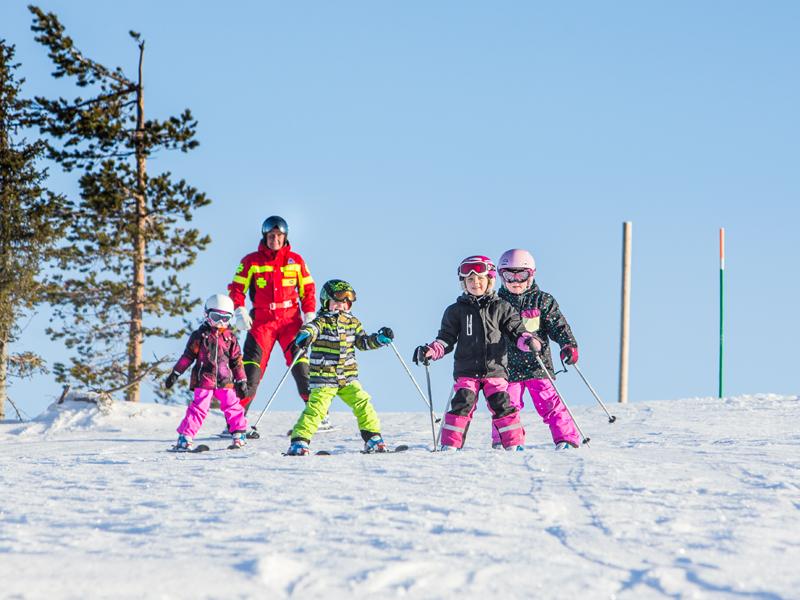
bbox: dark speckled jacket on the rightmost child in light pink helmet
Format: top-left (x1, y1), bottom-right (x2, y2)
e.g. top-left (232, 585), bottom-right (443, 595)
top-left (498, 281), bottom-right (578, 381)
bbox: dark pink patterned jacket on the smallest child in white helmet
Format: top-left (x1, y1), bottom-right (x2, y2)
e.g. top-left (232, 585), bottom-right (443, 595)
top-left (172, 323), bottom-right (247, 390)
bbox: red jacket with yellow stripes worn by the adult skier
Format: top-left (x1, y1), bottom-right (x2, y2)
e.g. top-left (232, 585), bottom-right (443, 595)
top-left (228, 241), bottom-right (316, 323)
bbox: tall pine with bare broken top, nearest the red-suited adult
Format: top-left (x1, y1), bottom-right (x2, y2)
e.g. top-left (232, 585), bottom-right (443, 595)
top-left (29, 6), bottom-right (210, 402)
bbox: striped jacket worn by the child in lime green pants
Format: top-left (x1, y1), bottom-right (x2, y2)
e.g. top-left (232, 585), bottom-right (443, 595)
top-left (300, 310), bottom-right (381, 388)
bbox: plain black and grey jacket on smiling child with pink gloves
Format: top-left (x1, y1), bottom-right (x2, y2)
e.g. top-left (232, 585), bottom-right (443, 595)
top-left (436, 292), bottom-right (525, 379)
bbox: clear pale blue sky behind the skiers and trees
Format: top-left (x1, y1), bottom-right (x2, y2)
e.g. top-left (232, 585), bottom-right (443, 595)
top-left (0, 1), bottom-right (800, 420)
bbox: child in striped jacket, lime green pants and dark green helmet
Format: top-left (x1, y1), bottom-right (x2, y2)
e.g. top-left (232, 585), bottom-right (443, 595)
top-left (286, 279), bottom-right (394, 456)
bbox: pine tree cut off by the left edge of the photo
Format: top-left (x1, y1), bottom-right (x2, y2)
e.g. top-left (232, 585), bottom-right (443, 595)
top-left (0, 39), bottom-right (70, 419)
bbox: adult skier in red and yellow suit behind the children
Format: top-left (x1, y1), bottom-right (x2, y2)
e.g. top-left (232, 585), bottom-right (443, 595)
top-left (228, 216), bottom-right (316, 437)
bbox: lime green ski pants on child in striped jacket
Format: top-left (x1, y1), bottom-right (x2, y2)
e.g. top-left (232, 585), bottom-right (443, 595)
top-left (292, 381), bottom-right (381, 442)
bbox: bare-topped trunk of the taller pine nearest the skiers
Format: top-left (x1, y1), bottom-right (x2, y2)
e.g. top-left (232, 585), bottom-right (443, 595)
top-left (125, 42), bottom-right (147, 402)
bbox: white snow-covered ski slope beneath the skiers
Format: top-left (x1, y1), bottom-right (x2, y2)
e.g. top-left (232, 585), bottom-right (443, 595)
top-left (0, 395), bottom-right (800, 600)
